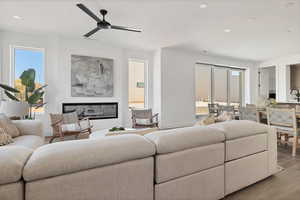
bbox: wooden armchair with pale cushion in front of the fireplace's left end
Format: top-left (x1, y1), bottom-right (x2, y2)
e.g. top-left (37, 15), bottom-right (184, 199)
top-left (49, 112), bottom-right (93, 143)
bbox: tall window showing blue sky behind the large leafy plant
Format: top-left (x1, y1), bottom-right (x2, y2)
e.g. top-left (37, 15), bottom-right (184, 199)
top-left (11, 47), bottom-right (45, 112)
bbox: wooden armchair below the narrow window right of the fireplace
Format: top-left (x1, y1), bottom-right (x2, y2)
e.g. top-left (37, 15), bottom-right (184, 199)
top-left (131, 109), bottom-right (158, 128)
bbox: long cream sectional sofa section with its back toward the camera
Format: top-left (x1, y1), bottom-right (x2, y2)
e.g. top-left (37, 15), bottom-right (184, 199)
top-left (0, 121), bottom-right (277, 200)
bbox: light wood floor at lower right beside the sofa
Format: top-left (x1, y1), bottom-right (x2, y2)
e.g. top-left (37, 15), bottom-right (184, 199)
top-left (225, 147), bottom-right (300, 200)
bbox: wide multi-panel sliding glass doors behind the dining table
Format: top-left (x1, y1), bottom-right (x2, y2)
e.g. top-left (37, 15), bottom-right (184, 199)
top-left (195, 64), bottom-right (244, 115)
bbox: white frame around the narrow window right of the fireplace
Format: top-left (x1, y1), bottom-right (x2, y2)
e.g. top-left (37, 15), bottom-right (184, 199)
top-left (127, 58), bottom-right (149, 109)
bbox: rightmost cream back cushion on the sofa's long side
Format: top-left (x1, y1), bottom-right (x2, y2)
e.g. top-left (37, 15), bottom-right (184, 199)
top-left (208, 120), bottom-right (268, 140)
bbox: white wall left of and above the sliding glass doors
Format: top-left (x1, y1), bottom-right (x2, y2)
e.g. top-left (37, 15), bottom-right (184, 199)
top-left (154, 48), bottom-right (256, 128)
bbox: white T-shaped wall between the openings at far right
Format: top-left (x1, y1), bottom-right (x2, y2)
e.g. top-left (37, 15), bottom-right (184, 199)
top-left (259, 54), bottom-right (300, 102)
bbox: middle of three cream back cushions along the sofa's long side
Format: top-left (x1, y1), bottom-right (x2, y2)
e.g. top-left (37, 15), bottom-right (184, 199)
top-left (145, 126), bottom-right (225, 154)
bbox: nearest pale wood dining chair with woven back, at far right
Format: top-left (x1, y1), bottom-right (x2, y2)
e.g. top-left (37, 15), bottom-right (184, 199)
top-left (267, 108), bottom-right (300, 156)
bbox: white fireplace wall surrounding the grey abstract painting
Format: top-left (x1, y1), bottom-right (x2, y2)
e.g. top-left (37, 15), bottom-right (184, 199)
top-left (0, 32), bottom-right (153, 135)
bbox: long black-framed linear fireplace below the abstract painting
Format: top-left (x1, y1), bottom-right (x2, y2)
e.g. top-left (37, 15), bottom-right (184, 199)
top-left (62, 102), bottom-right (118, 120)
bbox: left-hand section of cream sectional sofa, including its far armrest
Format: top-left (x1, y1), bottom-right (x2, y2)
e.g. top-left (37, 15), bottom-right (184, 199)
top-left (0, 120), bottom-right (44, 200)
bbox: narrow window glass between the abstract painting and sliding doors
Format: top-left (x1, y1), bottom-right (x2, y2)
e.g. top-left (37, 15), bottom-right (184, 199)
top-left (128, 59), bottom-right (147, 108)
